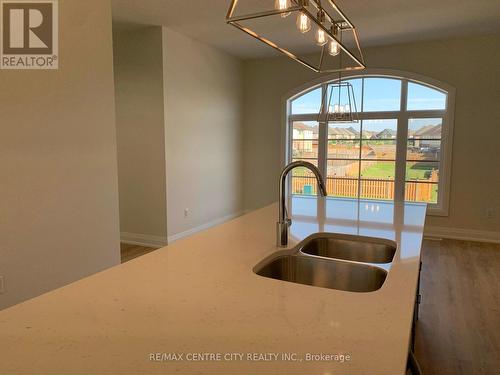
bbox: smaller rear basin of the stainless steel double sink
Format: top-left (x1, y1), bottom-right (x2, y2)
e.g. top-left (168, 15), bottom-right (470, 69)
top-left (299, 233), bottom-right (396, 263)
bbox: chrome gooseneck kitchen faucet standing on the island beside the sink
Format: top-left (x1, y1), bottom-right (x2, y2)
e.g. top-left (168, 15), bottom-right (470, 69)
top-left (276, 161), bottom-right (328, 247)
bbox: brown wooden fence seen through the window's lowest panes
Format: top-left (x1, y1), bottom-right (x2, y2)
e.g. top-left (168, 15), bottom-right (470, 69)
top-left (292, 176), bottom-right (436, 202)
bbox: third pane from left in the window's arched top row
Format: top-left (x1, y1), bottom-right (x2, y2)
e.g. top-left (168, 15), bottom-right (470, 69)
top-left (363, 78), bottom-right (401, 112)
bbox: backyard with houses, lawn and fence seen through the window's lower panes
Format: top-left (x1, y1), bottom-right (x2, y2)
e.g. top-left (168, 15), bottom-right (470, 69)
top-left (292, 121), bottom-right (441, 202)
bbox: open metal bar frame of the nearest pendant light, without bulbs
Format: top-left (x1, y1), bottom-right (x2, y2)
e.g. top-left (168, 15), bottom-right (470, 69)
top-left (226, 0), bottom-right (366, 73)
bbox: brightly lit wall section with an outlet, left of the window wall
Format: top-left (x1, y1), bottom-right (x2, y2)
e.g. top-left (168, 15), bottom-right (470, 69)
top-left (163, 28), bottom-right (243, 237)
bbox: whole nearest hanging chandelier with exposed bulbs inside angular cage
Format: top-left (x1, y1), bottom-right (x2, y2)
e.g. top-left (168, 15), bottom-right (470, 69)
top-left (226, 0), bottom-right (366, 73)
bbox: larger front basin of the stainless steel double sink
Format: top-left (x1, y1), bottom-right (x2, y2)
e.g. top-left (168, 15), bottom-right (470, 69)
top-left (255, 254), bottom-right (387, 293)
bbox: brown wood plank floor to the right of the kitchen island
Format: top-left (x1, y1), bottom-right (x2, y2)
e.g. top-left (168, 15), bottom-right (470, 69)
top-left (416, 240), bottom-right (500, 375)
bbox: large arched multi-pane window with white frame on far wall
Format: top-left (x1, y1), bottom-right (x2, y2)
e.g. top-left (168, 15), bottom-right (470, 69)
top-left (286, 71), bottom-right (454, 215)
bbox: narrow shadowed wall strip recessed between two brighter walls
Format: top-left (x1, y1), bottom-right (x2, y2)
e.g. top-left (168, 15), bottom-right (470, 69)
top-left (113, 25), bottom-right (167, 245)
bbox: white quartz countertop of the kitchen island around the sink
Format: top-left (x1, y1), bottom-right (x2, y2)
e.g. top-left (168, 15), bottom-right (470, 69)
top-left (0, 198), bottom-right (426, 375)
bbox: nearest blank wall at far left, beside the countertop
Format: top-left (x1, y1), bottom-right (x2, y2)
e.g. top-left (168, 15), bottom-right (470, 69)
top-left (0, 0), bottom-right (120, 308)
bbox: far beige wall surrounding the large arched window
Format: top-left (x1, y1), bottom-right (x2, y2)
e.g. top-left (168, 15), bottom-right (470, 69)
top-left (244, 35), bottom-right (500, 232)
